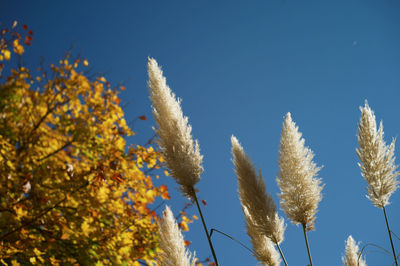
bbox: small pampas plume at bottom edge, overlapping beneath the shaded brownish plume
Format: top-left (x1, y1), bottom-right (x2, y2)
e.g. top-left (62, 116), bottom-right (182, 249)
top-left (243, 209), bottom-right (281, 266)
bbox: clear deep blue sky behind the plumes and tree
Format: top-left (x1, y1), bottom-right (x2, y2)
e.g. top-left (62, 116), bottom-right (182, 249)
top-left (0, 0), bottom-right (400, 266)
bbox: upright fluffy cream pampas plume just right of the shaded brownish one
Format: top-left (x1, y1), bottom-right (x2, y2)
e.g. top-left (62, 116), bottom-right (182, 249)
top-left (276, 113), bottom-right (323, 231)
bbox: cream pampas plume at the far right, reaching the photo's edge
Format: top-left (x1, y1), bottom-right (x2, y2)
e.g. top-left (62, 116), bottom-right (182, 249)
top-left (356, 102), bottom-right (399, 208)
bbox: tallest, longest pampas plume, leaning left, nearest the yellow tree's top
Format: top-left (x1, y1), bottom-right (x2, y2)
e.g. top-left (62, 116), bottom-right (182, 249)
top-left (147, 58), bottom-right (203, 199)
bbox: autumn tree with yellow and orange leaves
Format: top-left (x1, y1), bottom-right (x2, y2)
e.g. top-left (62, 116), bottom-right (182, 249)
top-left (0, 23), bottom-right (171, 265)
